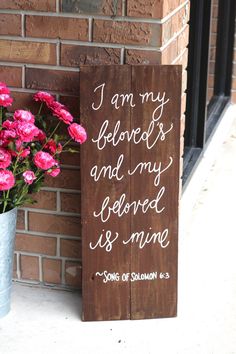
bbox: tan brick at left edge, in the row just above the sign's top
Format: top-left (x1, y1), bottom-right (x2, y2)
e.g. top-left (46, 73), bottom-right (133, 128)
top-left (0, 40), bottom-right (56, 64)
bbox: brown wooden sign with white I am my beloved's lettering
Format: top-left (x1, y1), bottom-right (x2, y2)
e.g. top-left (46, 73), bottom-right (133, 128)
top-left (80, 65), bottom-right (182, 321)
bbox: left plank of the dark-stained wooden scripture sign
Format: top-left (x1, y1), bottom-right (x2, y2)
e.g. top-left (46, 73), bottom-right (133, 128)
top-left (80, 66), bottom-right (131, 321)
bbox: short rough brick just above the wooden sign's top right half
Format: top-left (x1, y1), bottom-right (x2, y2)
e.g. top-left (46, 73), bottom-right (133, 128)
top-left (125, 49), bottom-right (161, 65)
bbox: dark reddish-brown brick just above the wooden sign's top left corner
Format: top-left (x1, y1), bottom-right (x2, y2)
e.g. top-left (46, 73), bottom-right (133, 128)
top-left (61, 44), bottom-right (120, 67)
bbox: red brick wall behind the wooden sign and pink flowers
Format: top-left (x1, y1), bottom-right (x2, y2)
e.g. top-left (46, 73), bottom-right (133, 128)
top-left (0, 0), bottom-right (189, 288)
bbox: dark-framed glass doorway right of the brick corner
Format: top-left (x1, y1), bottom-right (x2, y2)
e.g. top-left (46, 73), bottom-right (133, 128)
top-left (183, 0), bottom-right (236, 187)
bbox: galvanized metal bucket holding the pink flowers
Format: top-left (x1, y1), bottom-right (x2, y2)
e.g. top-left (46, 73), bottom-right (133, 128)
top-left (0, 208), bottom-right (17, 318)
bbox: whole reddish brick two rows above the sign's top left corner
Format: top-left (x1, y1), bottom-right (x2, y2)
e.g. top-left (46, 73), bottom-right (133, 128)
top-left (26, 16), bottom-right (88, 41)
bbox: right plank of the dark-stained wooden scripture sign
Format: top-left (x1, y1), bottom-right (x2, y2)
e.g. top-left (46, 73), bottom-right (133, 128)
top-left (131, 66), bottom-right (181, 319)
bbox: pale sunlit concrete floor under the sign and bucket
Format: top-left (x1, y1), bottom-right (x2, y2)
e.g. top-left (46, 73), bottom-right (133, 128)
top-left (0, 107), bottom-right (236, 354)
